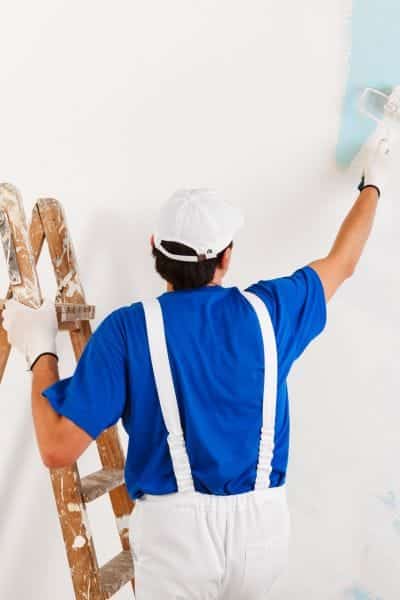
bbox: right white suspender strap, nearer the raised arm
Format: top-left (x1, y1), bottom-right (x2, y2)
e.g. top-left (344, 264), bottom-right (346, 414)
top-left (241, 290), bottom-right (278, 489)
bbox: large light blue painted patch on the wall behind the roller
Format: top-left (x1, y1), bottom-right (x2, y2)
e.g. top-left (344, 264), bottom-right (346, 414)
top-left (336, 0), bottom-right (400, 167)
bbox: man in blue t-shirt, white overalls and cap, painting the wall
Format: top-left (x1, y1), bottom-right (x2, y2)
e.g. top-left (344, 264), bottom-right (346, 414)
top-left (4, 140), bottom-right (389, 600)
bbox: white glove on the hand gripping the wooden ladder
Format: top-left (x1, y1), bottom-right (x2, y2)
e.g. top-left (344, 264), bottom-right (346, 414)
top-left (3, 298), bottom-right (58, 371)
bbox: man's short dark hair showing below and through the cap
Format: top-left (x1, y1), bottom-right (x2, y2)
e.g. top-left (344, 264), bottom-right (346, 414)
top-left (152, 241), bottom-right (233, 290)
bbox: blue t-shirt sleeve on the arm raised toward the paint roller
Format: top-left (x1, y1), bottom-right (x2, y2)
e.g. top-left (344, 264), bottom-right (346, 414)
top-left (248, 265), bottom-right (327, 369)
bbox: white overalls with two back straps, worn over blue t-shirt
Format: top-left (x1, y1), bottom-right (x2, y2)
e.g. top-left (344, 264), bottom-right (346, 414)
top-left (130, 291), bottom-right (291, 600)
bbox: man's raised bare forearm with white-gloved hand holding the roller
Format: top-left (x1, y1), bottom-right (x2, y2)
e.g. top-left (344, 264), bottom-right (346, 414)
top-left (309, 139), bottom-right (390, 301)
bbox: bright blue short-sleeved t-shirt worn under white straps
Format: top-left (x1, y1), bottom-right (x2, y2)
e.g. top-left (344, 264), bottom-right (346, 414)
top-left (42, 266), bottom-right (326, 499)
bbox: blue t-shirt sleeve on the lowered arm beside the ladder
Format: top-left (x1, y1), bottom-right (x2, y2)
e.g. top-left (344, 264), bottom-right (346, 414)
top-left (42, 309), bottom-right (127, 439)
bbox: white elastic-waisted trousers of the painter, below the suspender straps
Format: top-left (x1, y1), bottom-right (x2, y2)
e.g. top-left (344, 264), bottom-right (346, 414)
top-left (129, 484), bottom-right (291, 600)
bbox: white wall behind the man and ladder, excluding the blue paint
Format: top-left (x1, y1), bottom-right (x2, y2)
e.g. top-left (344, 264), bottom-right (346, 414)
top-left (0, 0), bottom-right (400, 600)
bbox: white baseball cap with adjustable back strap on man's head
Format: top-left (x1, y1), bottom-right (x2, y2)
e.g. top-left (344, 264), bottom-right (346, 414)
top-left (154, 188), bottom-right (244, 262)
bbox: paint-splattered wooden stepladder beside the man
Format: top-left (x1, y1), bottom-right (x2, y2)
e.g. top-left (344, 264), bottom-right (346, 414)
top-left (0, 184), bottom-right (135, 600)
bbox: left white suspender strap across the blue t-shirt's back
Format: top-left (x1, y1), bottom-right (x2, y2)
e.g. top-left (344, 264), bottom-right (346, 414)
top-left (142, 298), bottom-right (194, 492)
